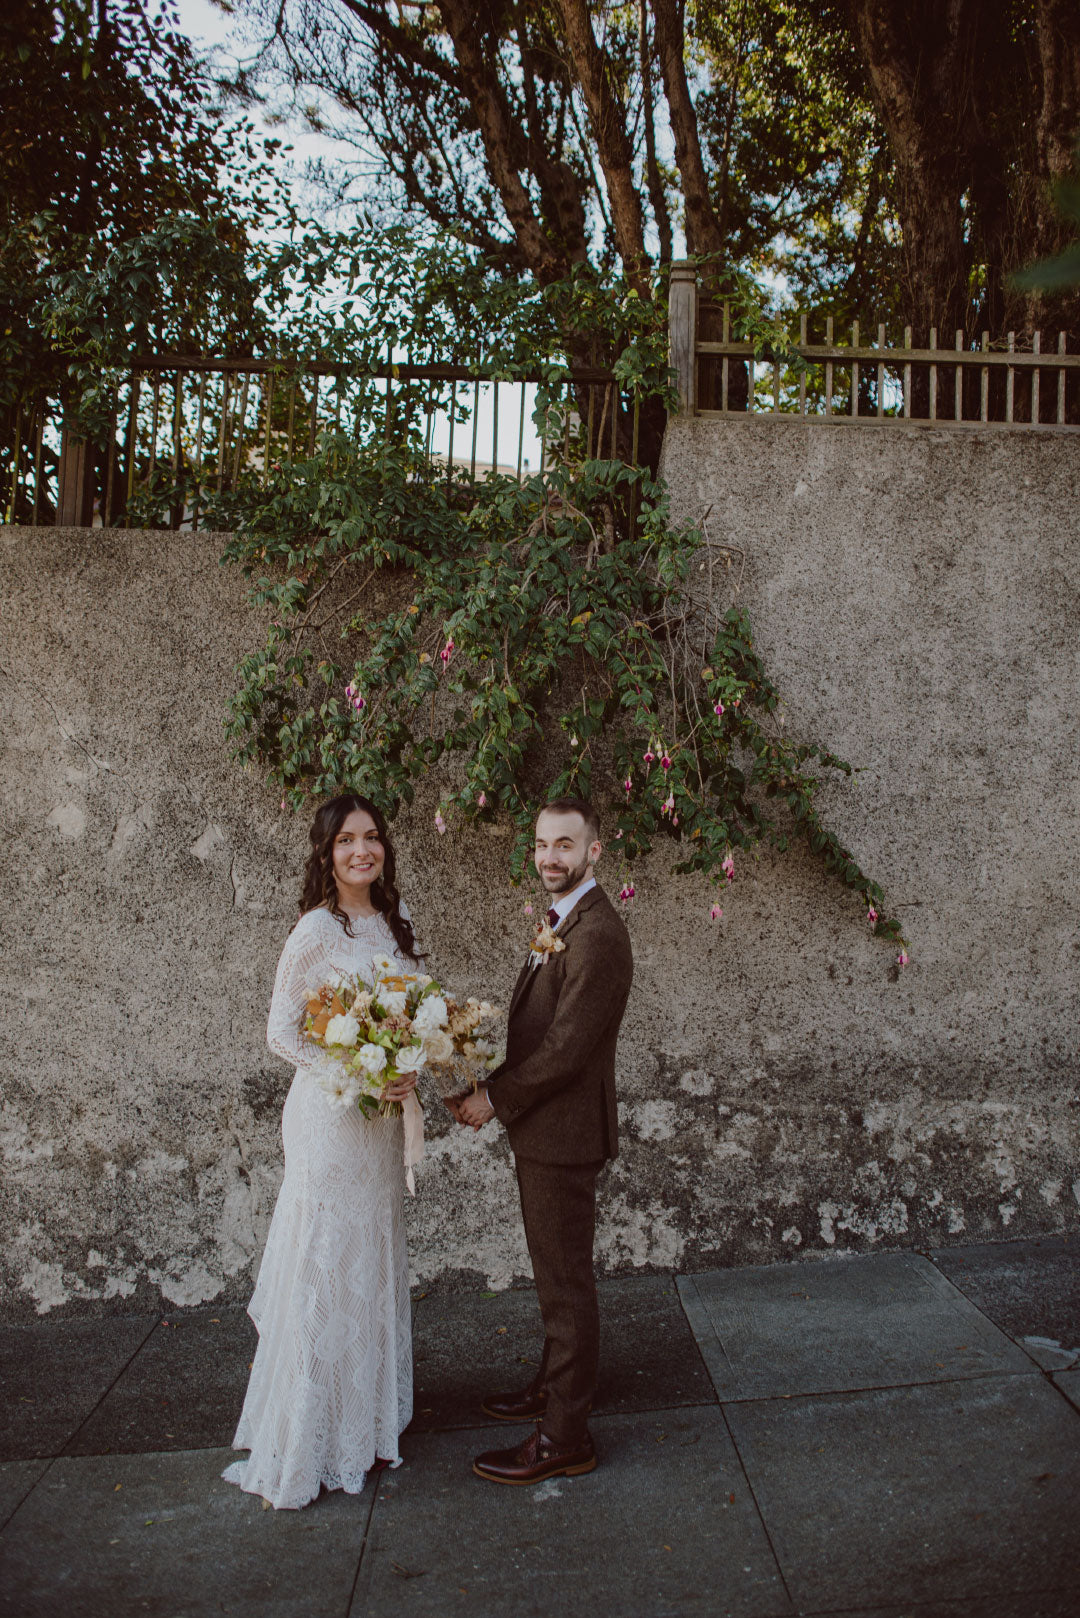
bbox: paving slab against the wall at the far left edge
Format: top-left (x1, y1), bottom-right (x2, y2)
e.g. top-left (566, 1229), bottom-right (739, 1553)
top-left (0, 1315), bottom-right (155, 1461)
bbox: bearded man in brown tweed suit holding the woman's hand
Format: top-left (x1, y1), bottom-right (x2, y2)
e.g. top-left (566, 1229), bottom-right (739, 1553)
top-left (447, 798), bottom-right (633, 1484)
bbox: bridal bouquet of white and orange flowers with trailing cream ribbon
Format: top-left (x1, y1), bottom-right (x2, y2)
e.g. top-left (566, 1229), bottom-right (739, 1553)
top-left (304, 955), bottom-right (497, 1196)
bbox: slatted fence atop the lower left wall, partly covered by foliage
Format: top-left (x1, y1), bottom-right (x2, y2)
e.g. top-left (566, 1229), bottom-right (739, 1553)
top-left (0, 354), bottom-right (638, 527)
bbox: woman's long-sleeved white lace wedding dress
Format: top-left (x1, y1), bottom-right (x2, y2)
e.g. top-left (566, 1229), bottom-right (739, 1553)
top-left (222, 909), bottom-right (413, 1508)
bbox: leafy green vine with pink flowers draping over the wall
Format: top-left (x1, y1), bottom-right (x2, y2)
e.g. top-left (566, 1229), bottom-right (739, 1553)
top-left (227, 252), bottom-right (907, 964)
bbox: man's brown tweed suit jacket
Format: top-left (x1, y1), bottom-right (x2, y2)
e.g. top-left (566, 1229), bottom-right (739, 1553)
top-left (487, 887), bottom-right (633, 1163)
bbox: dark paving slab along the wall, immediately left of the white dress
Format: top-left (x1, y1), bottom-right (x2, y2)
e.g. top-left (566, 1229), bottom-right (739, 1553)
top-left (65, 1309), bottom-right (257, 1455)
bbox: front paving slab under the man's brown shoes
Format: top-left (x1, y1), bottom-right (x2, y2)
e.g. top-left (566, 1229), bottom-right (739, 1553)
top-left (350, 1406), bottom-right (793, 1618)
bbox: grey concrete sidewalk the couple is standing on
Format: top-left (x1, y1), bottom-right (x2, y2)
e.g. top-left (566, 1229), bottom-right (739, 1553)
top-left (0, 1238), bottom-right (1080, 1618)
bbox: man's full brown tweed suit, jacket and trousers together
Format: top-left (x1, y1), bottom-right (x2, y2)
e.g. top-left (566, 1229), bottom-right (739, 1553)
top-left (487, 887), bottom-right (633, 1446)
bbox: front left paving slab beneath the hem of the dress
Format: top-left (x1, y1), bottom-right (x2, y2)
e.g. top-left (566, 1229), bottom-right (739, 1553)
top-left (0, 1450), bottom-right (374, 1618)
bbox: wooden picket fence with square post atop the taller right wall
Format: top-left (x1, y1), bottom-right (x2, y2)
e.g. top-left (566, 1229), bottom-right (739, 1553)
top-left (669, 264), bottom-right (1080, 432)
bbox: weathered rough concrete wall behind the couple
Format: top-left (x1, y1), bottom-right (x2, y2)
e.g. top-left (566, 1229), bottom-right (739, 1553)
top-left (0, 419), bottom-right (1080, 1317)
